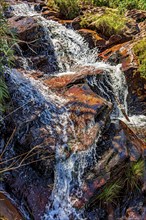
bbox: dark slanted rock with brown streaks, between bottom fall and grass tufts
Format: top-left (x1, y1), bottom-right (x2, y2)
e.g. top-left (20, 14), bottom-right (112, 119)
top-left (72, 121), bottom-right (143, 209)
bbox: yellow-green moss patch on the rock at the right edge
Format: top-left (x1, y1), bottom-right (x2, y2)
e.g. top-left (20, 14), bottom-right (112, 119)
top-left (133, 38), bottom-right (146, 79)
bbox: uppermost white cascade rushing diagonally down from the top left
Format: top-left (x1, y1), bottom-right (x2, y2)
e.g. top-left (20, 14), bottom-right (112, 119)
top-left (12, 4), bottom-right (97, 71)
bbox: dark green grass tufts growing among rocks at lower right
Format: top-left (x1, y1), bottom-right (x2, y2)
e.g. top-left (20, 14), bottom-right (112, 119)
top-left (87, 159), bottom-right (144, 208)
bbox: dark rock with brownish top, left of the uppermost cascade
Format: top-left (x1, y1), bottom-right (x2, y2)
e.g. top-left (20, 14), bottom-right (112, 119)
top-left (8, 17), bottom-right (58, 73)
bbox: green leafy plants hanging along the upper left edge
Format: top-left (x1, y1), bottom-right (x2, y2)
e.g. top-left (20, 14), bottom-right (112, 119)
top-left (0, 2), bottom-right (14, 111)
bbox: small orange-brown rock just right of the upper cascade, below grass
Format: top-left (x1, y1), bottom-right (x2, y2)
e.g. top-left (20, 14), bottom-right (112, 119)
top-left (78, 29), bottom-right (105, 51)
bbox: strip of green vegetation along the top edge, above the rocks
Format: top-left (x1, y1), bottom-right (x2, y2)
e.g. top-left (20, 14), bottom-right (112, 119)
top-left (47, 0), bottom-right (146, 18)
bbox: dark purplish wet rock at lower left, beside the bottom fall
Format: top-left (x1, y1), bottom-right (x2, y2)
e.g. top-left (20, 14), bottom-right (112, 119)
top-left (4, 166), bottom-right (53, 220)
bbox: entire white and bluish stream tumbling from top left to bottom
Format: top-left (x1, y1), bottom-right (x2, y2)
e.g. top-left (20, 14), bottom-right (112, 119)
top-left (0, 4), bottom-right (146, 220)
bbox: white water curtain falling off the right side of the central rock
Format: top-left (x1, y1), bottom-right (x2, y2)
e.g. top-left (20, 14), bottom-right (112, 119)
top-left (88, 62), bottom-right (128, 119)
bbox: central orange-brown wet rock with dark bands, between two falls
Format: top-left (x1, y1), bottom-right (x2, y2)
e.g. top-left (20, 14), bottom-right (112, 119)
top-left (63, 85), bottom-right (112, 151)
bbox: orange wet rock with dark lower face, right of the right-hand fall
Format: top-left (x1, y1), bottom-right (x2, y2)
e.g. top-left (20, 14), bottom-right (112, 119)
top-left (99, 38), bottom-right (146, 114)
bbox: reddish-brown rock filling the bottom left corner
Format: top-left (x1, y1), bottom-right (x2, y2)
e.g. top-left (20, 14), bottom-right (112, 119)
top-left (0, 191), bottom-right (23, 220)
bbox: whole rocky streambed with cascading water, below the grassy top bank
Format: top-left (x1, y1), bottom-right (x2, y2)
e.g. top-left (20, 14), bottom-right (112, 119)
top-left (0, 2), bottom-right (146, 220)
